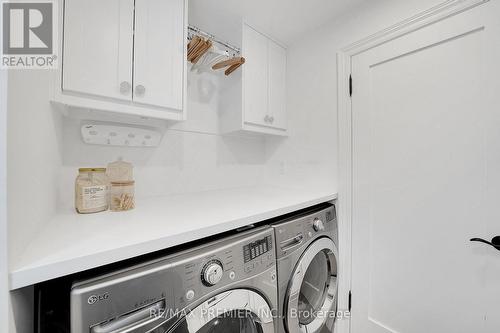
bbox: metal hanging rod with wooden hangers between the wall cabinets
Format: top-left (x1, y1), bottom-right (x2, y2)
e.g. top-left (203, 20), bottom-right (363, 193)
top-left (187, 25), bottom-right (245, 75)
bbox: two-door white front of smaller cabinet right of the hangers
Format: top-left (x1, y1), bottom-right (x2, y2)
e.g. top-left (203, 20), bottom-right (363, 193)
top-left (242, 24), bottom-right (287, 135)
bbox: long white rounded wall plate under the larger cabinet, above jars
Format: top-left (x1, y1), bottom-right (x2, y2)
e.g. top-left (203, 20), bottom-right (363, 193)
top-left (81, 124), bottom-right (162, 147)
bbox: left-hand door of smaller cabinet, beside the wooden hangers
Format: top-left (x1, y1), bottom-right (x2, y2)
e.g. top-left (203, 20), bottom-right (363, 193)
top-left (243, 25), bottom-right (269, 126)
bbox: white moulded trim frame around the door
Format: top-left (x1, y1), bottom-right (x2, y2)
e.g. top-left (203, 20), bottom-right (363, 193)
top-left (336, 0), bottom-right (490, 333)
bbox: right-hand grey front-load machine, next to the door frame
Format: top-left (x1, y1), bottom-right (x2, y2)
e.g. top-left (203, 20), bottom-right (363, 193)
top-left (272, 204), bottom-right (338, 333)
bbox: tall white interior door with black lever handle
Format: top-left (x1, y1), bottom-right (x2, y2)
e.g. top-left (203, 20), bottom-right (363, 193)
top-left (351, 1), bottom-right (500, 333)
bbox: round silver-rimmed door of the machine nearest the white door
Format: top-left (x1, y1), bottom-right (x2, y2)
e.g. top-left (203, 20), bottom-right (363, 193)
top-left (285, 238), bottom-right (338, 333)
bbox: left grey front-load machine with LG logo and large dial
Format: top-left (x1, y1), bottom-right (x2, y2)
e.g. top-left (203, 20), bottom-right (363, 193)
top-left (70, 227), bottom-right (278, 333)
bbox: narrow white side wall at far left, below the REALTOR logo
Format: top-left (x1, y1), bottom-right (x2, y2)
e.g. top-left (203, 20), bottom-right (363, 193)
top-left (7, 70), bottom-right (61, 265)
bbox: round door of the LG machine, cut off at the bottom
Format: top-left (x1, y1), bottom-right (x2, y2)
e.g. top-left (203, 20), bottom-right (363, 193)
top-left (164, 289), bottom-right (274, 333)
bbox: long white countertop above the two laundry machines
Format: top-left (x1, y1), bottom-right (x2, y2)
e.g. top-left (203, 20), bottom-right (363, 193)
top-left (10, 187), bottom-right (337, 290)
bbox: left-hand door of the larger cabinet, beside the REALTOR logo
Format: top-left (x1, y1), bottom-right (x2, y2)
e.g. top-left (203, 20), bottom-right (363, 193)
top-left (62, 0), bottom-right (134, 100)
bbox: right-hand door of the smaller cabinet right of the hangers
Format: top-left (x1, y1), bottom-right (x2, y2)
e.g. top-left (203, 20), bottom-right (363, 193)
top-left (268, 40), bottom-right (287, 129)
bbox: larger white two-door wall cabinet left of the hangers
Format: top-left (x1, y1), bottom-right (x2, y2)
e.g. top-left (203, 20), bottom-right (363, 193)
top-left (55, 0), bottom-right (187, 120)
